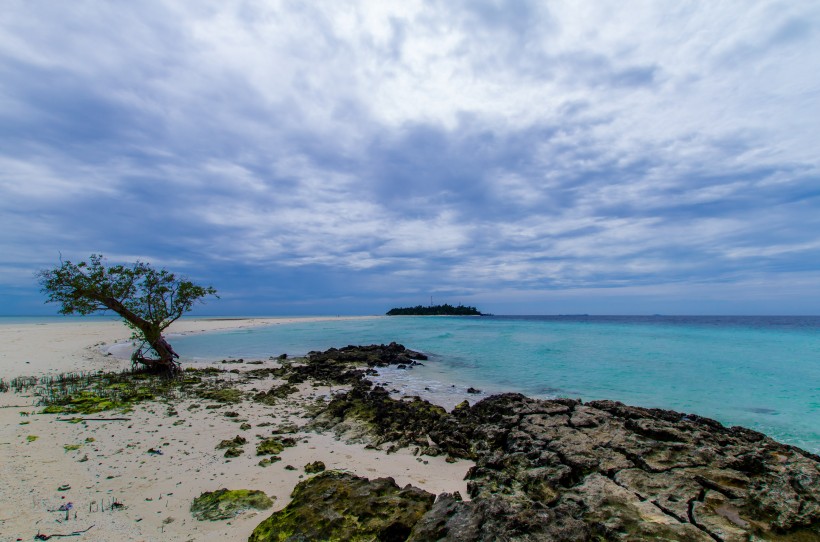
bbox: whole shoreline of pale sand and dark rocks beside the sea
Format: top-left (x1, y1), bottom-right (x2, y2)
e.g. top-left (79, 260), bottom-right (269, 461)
top-left (0, 321), bottom-right (820, 542)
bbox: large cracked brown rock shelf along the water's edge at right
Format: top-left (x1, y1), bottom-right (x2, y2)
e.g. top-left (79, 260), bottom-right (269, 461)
top-left (253, 351), bottom-right (820, 542)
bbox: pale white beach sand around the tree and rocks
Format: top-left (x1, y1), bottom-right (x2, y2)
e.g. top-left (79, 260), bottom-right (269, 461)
top-left (0, 319), bottom-right (472, 541)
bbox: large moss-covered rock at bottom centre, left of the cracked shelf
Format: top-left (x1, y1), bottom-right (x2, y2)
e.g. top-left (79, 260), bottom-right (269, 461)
top-left (248, 471), bottom-right (435, 542)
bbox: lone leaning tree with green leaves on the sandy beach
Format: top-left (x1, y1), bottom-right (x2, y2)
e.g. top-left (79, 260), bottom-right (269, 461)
top-left (37, 254), bottom-right (218, 373)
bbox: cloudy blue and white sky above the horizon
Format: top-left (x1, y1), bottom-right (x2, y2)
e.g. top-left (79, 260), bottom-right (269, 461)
top-left (0, 0), bottom-right (820, 315)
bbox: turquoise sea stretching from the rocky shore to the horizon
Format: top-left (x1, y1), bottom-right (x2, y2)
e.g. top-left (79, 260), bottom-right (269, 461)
top-left (168, 316), bottom-right (820, 453)
